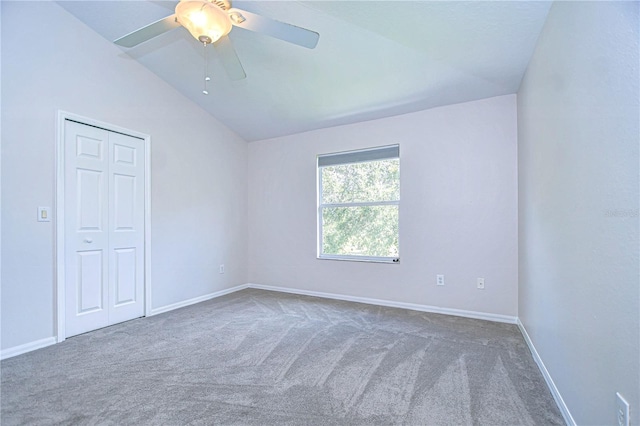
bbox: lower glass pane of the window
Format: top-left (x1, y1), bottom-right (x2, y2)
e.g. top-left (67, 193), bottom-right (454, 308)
top-left (322, 205), bottom-right (398, 257)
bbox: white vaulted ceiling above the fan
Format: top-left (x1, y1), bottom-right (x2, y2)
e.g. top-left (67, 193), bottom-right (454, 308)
top-left (59, 0), bottom-right (550, 141)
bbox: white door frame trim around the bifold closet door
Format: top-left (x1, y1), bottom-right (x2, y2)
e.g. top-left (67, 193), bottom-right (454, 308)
top-left (54, 110), bottom-right (151, 343)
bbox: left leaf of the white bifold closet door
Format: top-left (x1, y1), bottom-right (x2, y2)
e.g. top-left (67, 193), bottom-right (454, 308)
top-left (64, 121), bottom-right (109, 336)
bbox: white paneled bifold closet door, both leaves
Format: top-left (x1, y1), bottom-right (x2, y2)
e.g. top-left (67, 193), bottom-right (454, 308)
top-left (64, 120), bottom-right (145, 337)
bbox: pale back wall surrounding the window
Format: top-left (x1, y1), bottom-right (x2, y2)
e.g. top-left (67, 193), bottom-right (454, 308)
top-left (249, 95), bottom-right (518, 316)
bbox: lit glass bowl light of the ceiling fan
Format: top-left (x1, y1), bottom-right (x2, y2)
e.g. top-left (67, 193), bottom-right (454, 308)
top-left (176, 0), bottom-right (232, 44)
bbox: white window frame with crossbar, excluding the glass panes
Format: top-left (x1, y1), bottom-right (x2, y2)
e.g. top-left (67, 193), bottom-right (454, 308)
top-left (316, 144), bottom-right (401, 264)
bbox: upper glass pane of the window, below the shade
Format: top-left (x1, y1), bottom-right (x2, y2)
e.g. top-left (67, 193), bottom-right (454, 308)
top-left (320, 158), bottom-right (400, 204)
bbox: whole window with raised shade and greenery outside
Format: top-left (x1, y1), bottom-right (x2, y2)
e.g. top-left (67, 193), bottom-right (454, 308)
top-left (318, 145), bottom-right (400, 262)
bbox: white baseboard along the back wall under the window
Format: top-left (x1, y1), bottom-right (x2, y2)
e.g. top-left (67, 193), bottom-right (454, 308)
top-left (245, 283), bottom-right (518, 324)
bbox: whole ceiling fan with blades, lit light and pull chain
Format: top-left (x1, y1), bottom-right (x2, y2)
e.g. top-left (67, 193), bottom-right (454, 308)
top-left (114, 0), bottom-right (320, 85)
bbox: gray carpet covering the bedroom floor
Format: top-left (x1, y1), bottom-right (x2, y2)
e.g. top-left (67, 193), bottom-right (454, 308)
top-left (0, 290), bottom-right (564, 426)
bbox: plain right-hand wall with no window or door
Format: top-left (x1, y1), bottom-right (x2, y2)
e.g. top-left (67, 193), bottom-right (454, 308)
top-left (518, 2), bottom-right (640, 425)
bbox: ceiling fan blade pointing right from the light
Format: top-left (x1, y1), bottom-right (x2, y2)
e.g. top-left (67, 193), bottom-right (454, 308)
top-left (228, 9), bottom-right (320, 49)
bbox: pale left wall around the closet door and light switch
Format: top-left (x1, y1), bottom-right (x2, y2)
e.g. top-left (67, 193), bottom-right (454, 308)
top-left (1, 1), bottom-right (247, 349)
